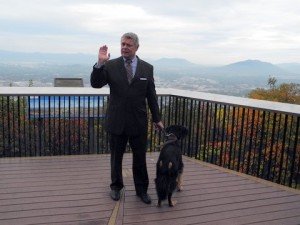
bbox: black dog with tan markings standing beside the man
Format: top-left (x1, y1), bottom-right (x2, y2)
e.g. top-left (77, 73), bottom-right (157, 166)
top-left (155, 125), bottom-right (188, 207)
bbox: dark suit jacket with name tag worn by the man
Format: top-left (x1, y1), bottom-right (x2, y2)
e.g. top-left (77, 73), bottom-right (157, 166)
top-left (90, 57), bottom-right (160, 135)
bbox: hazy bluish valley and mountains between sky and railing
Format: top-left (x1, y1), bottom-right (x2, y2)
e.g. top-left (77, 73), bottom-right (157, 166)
top-left (0, 50), bottom-right (300, 97)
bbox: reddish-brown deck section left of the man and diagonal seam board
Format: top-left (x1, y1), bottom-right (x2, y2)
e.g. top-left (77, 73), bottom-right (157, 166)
top-left (0, 155), bottom-right (115, 225)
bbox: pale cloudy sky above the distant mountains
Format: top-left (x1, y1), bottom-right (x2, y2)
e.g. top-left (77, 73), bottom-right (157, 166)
top-left (0, 0), bottom-right (300, 65)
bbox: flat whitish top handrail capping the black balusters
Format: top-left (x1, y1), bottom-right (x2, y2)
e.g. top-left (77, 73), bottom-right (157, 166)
top-left (0, 87), bottom-right (300, 115)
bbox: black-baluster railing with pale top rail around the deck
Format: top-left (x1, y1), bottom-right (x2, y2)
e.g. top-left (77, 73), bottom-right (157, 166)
top-left (0, 87), bottom-right (300, 188)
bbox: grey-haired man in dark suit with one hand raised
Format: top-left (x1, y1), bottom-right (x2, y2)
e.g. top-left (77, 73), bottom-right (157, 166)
top-left (91, 33), bottom-right (164, 204)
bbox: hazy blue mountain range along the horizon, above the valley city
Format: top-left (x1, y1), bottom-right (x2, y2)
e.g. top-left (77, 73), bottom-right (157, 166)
top-left (0, 50), bottom-right (300, 76)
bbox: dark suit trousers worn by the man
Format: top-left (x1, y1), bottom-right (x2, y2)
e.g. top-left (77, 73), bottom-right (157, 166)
top-left (109, 133), bottom-right (149, 195)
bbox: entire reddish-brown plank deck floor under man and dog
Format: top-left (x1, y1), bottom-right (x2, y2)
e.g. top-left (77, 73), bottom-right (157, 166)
top-left (0, 153), bottom-right (300, 225)
